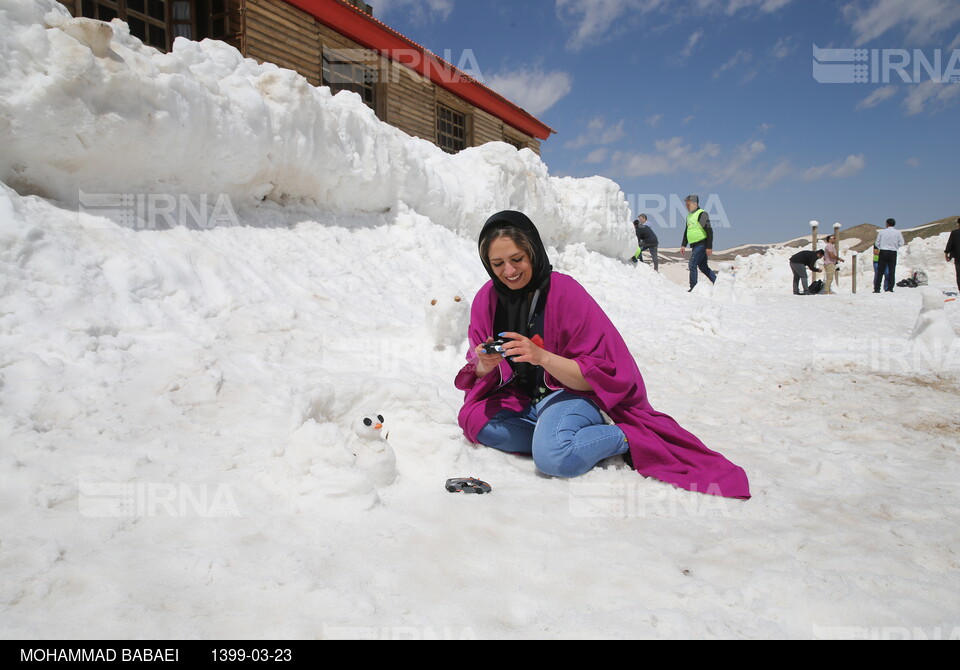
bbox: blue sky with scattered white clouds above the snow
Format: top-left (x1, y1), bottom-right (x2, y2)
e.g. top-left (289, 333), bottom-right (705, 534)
top-left (372, 0), bottom-right (960, 248)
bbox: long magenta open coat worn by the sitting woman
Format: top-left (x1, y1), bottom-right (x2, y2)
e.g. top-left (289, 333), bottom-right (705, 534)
top-left (456, 272), bottom-right (750, 499)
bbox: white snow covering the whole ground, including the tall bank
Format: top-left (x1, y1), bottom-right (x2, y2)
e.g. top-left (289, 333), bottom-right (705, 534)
top-left (0, 0), bottom-right (960, 639)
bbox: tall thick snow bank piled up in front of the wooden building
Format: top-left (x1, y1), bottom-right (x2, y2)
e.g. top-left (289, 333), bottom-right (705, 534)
top-left (0, 0), bottom-right (630, 256)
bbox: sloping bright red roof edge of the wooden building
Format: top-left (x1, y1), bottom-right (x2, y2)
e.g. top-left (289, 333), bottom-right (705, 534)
top-left (285, 0), bottom-right (556, 140)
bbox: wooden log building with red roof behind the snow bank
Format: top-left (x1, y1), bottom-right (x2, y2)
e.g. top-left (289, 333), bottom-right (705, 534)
top-left (61, 0), bottom-right (555, 153)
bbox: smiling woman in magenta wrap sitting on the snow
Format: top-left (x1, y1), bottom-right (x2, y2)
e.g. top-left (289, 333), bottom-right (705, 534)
top-left (456, 212), bottom-right (750, 498)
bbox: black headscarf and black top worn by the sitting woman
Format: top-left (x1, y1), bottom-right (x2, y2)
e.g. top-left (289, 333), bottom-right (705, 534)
top-left (479, 211), bottom-right (553, 397)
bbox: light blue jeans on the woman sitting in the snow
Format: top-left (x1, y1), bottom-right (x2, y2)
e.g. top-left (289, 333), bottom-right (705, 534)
top-left (477, 391), bottom-right (629, 478)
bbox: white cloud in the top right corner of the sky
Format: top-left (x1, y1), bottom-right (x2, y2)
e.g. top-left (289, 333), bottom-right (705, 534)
top-left (843, 0), bottom-right (960, 46)
